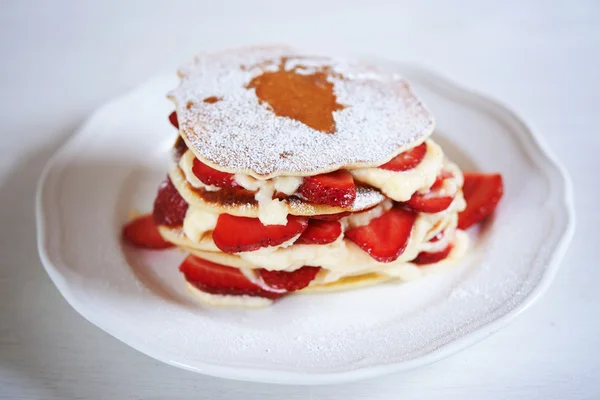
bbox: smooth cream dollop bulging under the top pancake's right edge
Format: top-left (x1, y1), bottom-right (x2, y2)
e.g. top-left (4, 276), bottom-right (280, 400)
top-left (350, 140), bottom-right (444, 202)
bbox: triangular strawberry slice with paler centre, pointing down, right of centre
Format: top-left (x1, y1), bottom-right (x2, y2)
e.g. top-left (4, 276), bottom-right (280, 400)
top-left (345, 205), bottom-right (417, 262)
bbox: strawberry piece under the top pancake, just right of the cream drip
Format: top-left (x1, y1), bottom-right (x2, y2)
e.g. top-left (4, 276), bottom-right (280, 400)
top-left (298, 169), bottom-right (356, 207)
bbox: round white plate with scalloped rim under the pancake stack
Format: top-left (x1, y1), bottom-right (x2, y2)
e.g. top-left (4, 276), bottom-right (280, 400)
top-left (37, 64), bottom-right (574, 384)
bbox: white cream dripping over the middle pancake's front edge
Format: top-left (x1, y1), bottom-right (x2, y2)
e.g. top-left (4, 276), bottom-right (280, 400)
top-left (234, 174), bottom-right (302, 225)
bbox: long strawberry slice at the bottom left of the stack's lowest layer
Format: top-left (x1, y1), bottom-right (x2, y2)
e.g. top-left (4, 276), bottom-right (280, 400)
top-left (179, 255), bottom-right (284, 299)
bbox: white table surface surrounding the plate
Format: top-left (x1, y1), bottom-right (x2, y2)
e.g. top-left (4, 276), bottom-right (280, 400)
top-left (0, 0), bottom-right (600, 400)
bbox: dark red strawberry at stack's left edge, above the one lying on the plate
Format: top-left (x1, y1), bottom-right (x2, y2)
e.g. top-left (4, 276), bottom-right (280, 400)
top-left (152, 177), bottom-right (188, 227)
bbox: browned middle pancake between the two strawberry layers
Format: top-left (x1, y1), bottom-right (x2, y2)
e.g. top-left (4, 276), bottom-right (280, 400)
top-left (169, 166), bottom-right (385, 218)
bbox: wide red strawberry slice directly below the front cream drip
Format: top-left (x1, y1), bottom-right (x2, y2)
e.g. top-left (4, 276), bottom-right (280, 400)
top-left (212, 214), bottom-right (308, 253)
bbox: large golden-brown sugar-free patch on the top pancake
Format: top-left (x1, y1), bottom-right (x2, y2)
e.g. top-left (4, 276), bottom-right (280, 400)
top-left (247, 58), bottom-right (344, 133)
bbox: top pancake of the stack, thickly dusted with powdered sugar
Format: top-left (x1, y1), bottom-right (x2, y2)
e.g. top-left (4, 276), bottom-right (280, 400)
top-left (169, 47), bottom-right (434, 179)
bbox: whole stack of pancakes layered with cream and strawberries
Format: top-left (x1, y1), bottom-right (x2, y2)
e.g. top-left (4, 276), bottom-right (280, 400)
top-left (154, 47), bottom-right (466, 304)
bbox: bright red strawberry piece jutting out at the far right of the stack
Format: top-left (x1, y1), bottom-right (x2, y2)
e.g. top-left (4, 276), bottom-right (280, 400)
top-left (458, 173), bottom-right (504, 229)
